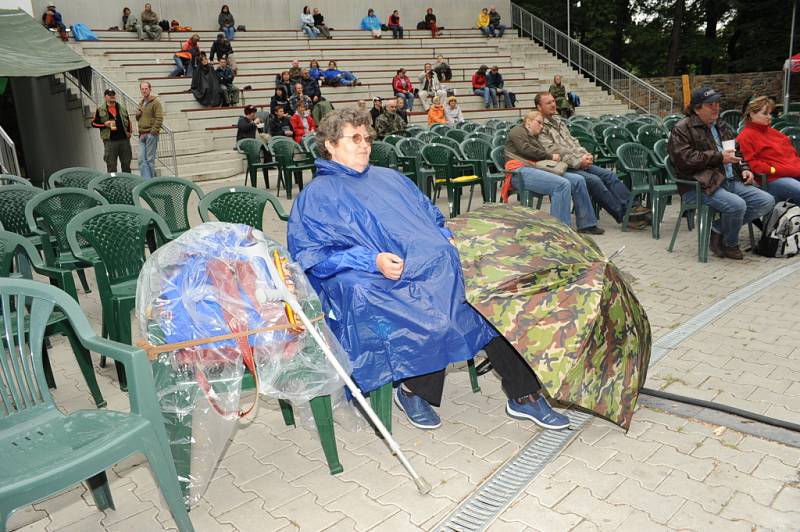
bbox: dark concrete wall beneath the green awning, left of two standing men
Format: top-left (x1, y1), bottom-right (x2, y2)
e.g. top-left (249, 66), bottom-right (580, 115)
top-left (11, 76), bottom-right (106, 183)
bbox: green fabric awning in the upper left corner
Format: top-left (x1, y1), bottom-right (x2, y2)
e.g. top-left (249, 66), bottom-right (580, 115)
top-left (0, 9), bottom-right (89, 78)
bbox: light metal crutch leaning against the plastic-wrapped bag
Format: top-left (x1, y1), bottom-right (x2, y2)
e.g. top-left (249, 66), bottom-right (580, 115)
top-left (266, 260), bottom-right (431, 494)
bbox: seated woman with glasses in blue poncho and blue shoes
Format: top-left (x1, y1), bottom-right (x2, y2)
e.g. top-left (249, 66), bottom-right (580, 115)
top-left (287, 109), bottom-right (569, 429)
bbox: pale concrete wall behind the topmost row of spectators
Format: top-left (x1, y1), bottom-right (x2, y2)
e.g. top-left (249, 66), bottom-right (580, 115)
top-left (32, 0), bottom-right (511, 29)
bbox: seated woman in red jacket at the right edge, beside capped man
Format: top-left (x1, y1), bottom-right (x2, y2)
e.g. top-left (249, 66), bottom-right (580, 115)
top-left (736, 96), bottom-right (800, 205)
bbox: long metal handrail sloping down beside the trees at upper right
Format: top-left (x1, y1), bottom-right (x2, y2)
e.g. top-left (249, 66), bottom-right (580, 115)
top-left (511, 3), bottom-right (674, 116)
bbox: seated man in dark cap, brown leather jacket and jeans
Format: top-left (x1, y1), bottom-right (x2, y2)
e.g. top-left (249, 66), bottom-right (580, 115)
top-left (667, 87), bottom-right (775, 260)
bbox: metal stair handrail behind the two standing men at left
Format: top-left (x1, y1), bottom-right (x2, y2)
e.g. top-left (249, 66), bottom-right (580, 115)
top-left (64, 67), bottom-right (178, 177)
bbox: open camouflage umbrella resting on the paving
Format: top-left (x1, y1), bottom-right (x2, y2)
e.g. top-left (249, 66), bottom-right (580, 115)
top-left (449, 204), bottom-right (651, 429)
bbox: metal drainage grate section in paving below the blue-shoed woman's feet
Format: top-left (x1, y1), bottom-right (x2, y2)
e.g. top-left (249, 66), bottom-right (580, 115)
top-left (435, 410), bottom-right (592, 532)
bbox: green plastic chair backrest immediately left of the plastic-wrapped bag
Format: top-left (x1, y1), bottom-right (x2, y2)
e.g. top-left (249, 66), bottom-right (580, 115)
top-left (67, 204), bottom-right (173, 286)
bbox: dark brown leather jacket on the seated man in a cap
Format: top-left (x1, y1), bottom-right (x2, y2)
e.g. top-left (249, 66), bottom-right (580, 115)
top-left (667, 114), bottom-right (750, 194)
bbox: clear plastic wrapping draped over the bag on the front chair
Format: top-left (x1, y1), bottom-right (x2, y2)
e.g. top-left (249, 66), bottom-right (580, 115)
top-left (136, 222), bottom-right (351, 505)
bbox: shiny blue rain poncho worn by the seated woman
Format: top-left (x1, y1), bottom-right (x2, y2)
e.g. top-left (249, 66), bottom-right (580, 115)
top-left (287, 159), bottom-right (497, 392)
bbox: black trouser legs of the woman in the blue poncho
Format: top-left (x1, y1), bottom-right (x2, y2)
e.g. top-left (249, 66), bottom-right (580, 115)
top-left (403, 336), bottom-right (541, 406)
